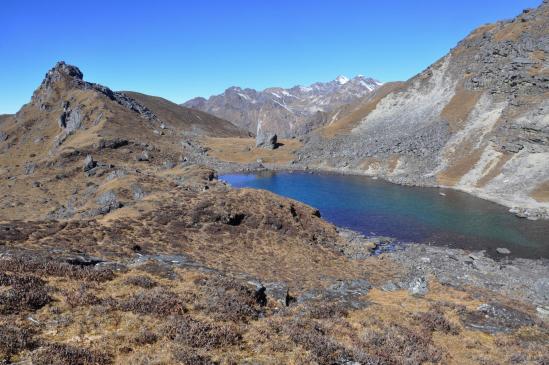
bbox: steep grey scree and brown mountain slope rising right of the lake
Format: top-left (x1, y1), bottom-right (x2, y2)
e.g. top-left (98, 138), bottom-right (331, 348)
top-left (300, 1), bottom-right (549, 218)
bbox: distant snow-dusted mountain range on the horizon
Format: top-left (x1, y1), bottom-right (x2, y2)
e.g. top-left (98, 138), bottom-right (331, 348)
top-left (182, 75), bottom-right (382, 137)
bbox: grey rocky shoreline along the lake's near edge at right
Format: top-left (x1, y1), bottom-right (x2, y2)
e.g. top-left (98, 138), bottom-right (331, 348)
top-left (338, 228), bottom-right (549, 319)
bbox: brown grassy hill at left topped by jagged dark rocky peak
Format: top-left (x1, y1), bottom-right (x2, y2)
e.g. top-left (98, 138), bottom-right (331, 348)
top-left (0, 63), bottom-right (245, 219)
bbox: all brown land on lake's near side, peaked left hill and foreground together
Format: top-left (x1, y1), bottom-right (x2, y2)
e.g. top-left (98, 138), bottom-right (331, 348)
top-left (0, 63), bottom-right (549, 365)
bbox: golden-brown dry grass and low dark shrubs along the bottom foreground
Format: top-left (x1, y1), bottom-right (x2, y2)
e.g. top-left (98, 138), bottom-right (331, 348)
top-left (0, 243), bottom-right (549, 365)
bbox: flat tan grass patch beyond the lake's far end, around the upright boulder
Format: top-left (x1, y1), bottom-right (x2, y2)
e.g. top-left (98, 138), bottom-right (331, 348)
top-left (199, 138), bottom-right (302, 164)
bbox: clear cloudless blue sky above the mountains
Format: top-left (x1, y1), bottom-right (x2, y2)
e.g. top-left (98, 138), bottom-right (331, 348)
top-left (0, 0), bottom-right (541, 114)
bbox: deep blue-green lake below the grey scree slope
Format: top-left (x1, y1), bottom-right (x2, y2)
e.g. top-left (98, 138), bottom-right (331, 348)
top-left (221, 172), bottom-right (549, 258)
